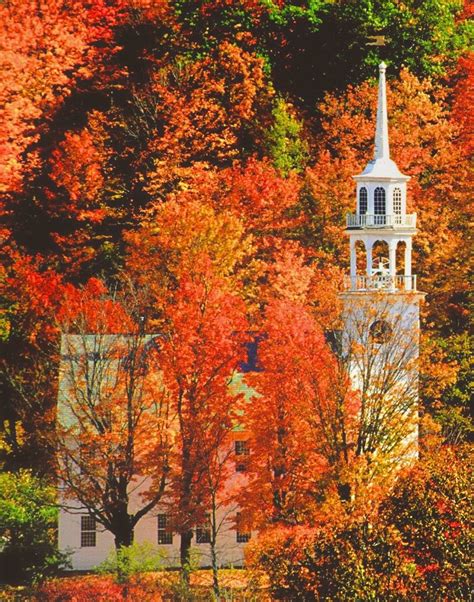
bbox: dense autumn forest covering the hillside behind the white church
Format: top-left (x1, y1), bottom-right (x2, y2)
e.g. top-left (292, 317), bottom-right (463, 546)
top-left (0, 0), bottom-right (474, 599)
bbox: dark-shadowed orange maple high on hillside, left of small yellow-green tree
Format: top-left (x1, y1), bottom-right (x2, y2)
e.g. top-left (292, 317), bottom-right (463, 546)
top-left (104, 42), bottom-right (271, 203)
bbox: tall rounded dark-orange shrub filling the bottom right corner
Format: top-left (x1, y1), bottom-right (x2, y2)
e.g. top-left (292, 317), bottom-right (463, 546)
top-left (382, 446), bottom-right (474, 600)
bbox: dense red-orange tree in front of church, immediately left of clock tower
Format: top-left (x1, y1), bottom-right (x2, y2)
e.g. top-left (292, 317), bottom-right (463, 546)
top-left (241, 300), bottom-right (338, 527)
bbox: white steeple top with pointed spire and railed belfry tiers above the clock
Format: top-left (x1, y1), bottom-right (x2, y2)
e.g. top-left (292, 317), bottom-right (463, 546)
top-left (346, 63), bottom-right (416, 292)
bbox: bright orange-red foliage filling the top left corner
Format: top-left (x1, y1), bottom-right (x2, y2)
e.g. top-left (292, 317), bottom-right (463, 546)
top-left (0, 0), bottom-right (125, 192)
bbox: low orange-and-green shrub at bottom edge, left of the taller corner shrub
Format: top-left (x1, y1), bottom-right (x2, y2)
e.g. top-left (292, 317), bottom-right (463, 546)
top-left (247, 516), bottom-right (415, 602)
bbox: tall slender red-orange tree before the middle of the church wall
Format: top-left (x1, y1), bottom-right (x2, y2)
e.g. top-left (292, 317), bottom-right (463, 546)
top-left (158, 256), bottom-right (250, 582)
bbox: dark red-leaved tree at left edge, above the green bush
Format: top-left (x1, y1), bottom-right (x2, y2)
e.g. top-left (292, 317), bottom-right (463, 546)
top-left (0, 246), bottom-right (65, 474)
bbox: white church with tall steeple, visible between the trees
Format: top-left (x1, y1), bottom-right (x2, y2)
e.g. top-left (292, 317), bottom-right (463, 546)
top-left (58, 63), bottom-right (424, 570)
